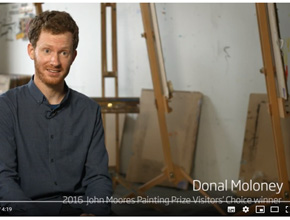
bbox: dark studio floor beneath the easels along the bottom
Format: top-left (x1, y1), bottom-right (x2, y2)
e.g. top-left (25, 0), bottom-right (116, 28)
top-left (112, 182), bottom-right (290, 216)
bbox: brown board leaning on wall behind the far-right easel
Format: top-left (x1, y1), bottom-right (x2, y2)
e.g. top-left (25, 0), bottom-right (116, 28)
top-left (237, 94), bottom-right (290, 197)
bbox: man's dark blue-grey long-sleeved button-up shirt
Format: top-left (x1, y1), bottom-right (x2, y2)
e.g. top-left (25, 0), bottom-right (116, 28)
top-left (0, 78), bottom-right (112, 215)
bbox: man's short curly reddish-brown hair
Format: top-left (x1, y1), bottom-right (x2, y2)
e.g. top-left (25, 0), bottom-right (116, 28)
top-left (28, 11), bottom-right (79, 50)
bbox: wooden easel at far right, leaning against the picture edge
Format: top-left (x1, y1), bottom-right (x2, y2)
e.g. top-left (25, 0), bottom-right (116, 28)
top-left (238, 3), bottom-right (289, 215)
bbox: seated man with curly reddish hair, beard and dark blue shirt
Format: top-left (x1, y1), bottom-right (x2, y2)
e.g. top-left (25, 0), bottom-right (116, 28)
top-left (0, 11), bottom-right (112, 215)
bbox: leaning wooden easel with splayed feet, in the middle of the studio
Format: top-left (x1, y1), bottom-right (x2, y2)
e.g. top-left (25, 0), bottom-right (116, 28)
top-left (120, 3), bottom-right (225, 215)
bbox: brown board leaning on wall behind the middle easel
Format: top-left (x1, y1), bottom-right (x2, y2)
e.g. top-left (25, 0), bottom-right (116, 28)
top-left (127, 90), bottom-right (202, 188)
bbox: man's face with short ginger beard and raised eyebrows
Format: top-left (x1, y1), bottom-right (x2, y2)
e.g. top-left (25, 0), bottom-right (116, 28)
top-left (28, 31), bottom-right (76, 87)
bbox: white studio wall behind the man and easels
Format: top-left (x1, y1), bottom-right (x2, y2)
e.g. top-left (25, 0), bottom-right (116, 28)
top-left (0, 3), bottom-right (266, 186)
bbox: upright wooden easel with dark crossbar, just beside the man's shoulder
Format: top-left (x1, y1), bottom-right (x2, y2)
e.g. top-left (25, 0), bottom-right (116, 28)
top-left (99, 3), bottom-right (144, 192)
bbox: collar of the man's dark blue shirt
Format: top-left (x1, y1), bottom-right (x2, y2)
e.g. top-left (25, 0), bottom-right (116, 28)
top-left (28, 75), bottom-right (71, 106)
